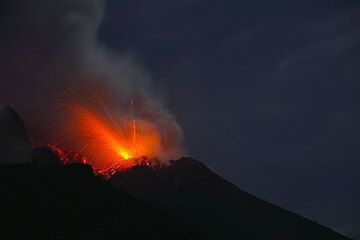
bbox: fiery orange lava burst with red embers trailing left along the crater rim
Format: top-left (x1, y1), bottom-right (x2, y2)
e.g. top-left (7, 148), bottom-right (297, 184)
top-left (35, 91), bottom-right (167, 175)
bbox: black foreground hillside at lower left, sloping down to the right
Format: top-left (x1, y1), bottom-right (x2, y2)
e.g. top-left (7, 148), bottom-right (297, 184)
top-left (0, 164), bottom-right (203, 240)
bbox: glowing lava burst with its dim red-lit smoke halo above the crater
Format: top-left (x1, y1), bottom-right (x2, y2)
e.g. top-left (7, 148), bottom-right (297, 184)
top-left (28, 87), bottom-right (180, 175)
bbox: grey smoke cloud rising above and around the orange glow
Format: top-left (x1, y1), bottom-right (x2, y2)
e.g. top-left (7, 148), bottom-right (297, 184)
top-left (0, 0), bottom-right (182, 162)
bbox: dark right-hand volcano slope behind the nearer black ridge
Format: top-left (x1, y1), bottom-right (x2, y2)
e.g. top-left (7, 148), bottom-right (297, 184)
top-left (110, 158), bottom-right (348, 240)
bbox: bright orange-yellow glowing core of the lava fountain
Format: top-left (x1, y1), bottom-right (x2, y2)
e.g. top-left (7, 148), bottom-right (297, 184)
top-left (56, 104), bottom-right (161, 173)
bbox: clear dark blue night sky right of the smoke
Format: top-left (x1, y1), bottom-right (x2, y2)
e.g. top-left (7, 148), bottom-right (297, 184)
top-left (99, 0), bottom-right (360, 239)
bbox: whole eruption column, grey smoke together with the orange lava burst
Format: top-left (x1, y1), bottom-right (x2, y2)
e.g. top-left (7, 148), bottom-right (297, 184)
top-left (0, 0), bottom-right (182, 172)
